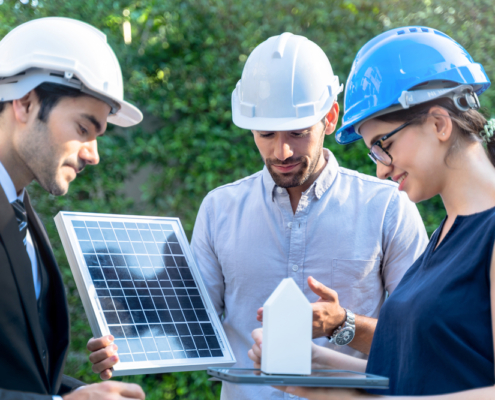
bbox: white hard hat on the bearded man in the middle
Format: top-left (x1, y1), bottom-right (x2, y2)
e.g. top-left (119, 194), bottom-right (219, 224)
top-left (232, 32), bottom-right (342, 131)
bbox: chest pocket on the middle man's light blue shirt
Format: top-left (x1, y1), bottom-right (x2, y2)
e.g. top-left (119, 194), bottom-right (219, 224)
top-left (332, 259), bottom-right (383, 315)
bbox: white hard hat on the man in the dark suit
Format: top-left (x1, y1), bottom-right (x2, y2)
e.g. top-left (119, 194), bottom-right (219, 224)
top-left (0, 17), bottom-right (143, 126)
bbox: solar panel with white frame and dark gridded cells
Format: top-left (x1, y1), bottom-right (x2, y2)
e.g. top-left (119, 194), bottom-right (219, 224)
top-left (55, 212), bottom-right (235, 376)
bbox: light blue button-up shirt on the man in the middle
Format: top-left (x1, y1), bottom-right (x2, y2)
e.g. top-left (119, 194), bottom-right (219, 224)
top-left (191, 149), bottom-right (428, 400)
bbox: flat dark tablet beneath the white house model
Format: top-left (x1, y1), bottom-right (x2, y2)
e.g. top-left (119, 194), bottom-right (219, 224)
top-left (208, 367), bottom-right (388, 389)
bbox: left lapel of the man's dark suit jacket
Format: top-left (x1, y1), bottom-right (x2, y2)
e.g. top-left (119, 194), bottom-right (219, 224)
top-left (0, 187), bottom-right (49, 387)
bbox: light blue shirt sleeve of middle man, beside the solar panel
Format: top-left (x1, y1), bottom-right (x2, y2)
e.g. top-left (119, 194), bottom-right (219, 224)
top-left (191, 196), bottom-right (225, 317)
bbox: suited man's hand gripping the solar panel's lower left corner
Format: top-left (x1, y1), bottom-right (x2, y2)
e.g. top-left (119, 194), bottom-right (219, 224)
top-left (86, 335), bottom-right (119, 380)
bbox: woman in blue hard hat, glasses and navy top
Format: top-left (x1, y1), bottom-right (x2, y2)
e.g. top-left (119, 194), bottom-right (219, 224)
top-left (250, 27), bottom-right (495, 400)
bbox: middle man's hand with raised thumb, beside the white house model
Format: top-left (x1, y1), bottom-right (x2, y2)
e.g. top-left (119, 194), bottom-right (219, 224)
top-left (308, 276), bottom-right (347, 338)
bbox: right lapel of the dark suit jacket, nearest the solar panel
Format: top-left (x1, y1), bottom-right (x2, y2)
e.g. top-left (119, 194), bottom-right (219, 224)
top-left (24, 192), bottom-right (69, 389)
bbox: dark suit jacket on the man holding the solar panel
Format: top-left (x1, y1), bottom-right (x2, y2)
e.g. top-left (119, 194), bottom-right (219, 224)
top-left (0, 186), bottom-right (81, 400)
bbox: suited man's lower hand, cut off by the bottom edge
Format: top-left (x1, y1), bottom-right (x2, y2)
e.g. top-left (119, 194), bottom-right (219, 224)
top-left (63, 381), bottom-right (145, 400)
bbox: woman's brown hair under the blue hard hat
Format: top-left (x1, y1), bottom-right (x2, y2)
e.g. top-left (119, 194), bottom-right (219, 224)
top-left (377, 98), bottom-right (495, 166)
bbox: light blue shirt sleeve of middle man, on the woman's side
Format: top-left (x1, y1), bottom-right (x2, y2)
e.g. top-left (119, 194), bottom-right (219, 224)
top-left (382, 193), bottom-right (428, 293)
